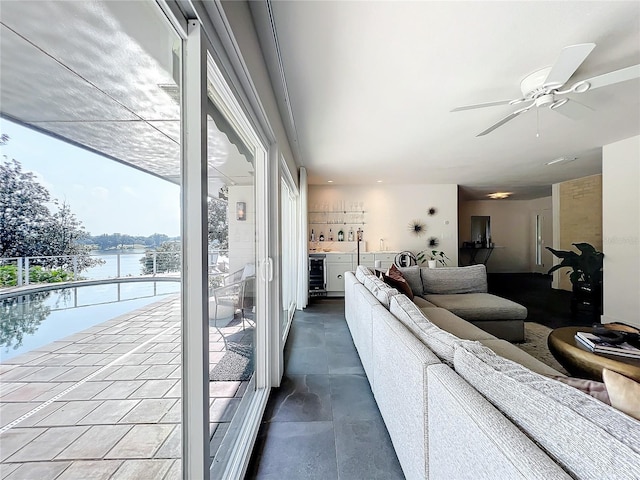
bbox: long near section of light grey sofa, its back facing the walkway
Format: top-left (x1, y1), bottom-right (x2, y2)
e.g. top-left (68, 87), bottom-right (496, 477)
top-left (345, 267), bottom-right (640, 480)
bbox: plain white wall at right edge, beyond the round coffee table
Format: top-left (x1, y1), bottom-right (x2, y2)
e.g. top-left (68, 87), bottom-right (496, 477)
top-left (602, 136), bottom-right (640, 327)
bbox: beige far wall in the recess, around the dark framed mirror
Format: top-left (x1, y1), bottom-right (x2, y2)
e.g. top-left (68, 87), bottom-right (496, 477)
top-left (458, 197), bottom-right (551, 273)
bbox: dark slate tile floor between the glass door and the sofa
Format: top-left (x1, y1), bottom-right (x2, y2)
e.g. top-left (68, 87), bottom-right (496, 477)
top-left (246, 298), bottom-right (404, 480)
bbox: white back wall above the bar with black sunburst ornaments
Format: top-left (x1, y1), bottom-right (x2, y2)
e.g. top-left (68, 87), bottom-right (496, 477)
top-left (308, 184), bottom-right (458, 265)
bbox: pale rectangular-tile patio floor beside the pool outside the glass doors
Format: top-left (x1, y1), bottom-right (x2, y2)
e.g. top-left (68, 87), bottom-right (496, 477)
top-left (0, 296), bottom-right (246, 480)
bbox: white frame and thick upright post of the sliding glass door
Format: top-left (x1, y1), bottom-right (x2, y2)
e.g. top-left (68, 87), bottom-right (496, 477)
top-left (169, 5), bottom-right (278, 480)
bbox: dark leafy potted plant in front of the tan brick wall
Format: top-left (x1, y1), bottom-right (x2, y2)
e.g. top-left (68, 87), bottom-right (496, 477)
top-left (547, 243), bottom-right (604, 315)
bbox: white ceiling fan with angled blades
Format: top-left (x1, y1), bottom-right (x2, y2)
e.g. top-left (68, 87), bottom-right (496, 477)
top-left (451, 43), bottom-right (640, 137)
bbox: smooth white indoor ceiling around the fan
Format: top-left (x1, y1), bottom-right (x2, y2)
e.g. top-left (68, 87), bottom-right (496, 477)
top-left (254, 1), bottom-right (640, 199)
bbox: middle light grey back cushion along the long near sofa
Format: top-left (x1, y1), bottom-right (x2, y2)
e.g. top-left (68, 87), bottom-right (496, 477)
top-left (389, 295), bottom-right (461, 364)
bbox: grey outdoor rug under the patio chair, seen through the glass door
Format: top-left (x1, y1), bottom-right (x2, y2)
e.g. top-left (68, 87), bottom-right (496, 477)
top-left (209, 332), bottom-right (254, 382)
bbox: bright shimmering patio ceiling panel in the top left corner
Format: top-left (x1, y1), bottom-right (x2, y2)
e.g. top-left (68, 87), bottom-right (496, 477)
top-left (2, 1), bottom-right (180, 120)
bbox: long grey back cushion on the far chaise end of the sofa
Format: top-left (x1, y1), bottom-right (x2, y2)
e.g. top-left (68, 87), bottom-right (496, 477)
top-left (420, 265), bottom-right (487, 295)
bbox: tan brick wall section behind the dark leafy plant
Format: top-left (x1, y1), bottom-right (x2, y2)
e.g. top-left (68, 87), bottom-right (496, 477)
top-left (554, 175), bottom-right (602, 291)
